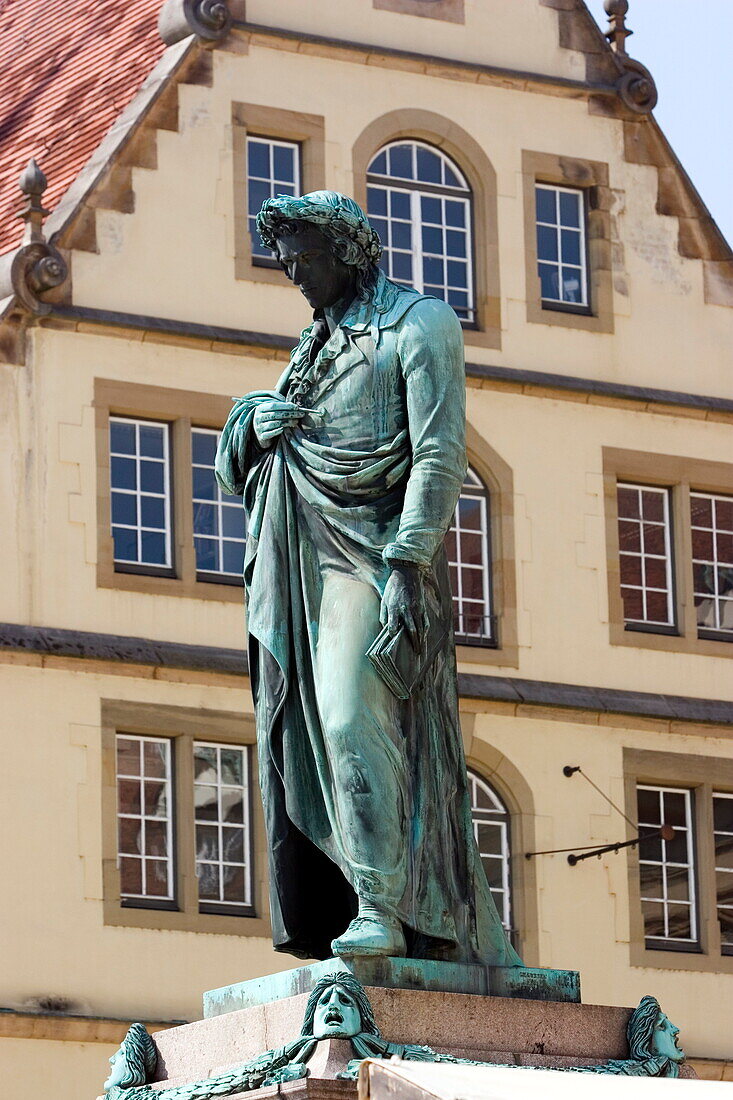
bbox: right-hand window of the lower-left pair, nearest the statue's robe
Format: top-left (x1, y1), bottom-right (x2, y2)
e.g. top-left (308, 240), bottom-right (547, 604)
top-left (194, 741), bottom-right (252, 914)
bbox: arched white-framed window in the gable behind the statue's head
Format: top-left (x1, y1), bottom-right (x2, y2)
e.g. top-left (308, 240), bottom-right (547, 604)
top-left (367, 141), bottom-right (475, 322)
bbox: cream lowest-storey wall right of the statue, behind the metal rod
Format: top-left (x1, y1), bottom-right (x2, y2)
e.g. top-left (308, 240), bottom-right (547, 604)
top-left (469, 714), bottom-right (733, 1058)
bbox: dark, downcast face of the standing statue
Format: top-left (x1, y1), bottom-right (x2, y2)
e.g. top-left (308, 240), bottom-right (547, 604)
top-left (276, 226), bottom-right (355, 309)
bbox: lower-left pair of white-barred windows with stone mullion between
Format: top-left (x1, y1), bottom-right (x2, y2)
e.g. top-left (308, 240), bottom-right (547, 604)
top-left (107, 704), bottom-right (260, 928)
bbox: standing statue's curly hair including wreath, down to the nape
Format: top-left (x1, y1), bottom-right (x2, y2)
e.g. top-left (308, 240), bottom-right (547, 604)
top-left (256, 191), bottom-right (382, 298)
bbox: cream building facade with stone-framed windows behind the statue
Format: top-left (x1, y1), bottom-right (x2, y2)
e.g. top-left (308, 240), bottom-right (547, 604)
top-left (0, 0), bottom-right (733, 1100)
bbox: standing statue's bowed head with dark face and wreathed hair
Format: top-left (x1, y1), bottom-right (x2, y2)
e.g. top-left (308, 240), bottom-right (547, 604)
top-left (258, 191), bottom-right (382, 309)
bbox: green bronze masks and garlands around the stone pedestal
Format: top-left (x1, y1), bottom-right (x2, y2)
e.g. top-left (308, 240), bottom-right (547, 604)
top-left (105, 972), bottom-right (685, 1100)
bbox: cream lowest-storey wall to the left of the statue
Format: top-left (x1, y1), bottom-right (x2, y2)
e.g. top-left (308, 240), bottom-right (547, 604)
top-left (0, 662), bottom-right (293, 1021)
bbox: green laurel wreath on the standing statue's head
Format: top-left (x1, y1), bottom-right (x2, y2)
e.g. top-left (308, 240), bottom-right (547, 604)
top-left (256, 191), bottom-right (382, 266)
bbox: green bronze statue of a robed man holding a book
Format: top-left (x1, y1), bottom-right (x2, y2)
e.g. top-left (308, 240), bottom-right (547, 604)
top-left (217, 191), bottom-right (521, 966)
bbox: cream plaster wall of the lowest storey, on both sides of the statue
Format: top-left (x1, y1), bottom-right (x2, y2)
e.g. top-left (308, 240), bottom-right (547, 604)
top-left (0, 660), bottom-right (733, 1060)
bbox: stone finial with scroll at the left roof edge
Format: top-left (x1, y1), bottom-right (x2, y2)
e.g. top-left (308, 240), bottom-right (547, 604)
top-left (0, 160), bottom-right (68, 316)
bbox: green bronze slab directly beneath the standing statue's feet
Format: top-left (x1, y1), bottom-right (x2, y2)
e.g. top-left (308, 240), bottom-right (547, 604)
top-left (204, 956), bottom-right (580, 1018)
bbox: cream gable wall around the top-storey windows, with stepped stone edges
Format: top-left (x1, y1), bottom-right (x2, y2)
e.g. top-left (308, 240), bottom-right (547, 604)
top-left (73, 36), bottom-right (733, 396)
